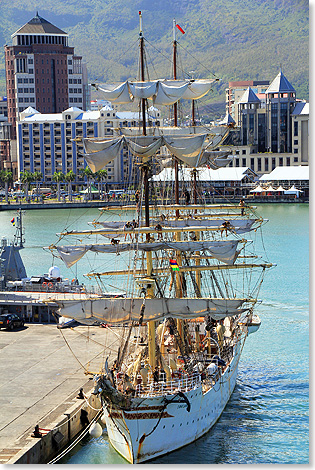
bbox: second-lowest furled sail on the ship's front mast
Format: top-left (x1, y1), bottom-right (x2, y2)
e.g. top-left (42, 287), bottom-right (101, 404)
top-left (57, 240), bottom-right (238, 268)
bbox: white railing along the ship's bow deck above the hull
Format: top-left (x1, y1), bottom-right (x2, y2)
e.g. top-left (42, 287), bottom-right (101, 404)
top-left (135, 374), bottom-right (201, 397)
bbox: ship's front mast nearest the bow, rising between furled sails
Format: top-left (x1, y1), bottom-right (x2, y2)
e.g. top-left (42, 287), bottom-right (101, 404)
top-left (139, 11), bottom-right (156, 371)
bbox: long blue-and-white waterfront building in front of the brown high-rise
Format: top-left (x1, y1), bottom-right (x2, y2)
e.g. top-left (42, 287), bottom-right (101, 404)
top-left (17, 106), bottom-right (160, 185)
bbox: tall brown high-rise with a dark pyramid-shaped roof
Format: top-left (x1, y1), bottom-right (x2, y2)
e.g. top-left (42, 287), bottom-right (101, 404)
top-left (4, 13), bottom-right (87, 139)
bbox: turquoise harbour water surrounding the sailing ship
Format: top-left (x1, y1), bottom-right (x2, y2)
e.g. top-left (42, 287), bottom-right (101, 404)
top-left (0, 204), bottom-right (309, 464)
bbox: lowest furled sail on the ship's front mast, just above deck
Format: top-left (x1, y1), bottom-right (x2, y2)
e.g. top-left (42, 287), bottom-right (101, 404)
top-left (56, 298), bottom-right (246, 324)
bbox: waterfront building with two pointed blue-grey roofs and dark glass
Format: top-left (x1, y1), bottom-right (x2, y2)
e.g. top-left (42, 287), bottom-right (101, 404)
top-left (220, 71), bottom-right (309, 175)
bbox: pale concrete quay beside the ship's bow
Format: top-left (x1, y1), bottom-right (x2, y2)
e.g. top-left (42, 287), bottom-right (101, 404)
top-left (0, 324), bottom-right (120, 464)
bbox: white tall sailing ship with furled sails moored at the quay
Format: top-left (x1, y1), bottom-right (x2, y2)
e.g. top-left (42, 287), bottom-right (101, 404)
top-left (51, 13), bottom-right (272, 463)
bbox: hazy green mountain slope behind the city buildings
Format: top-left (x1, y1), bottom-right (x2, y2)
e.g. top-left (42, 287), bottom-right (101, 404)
top-left (0, 0), bottom-right (309, 117)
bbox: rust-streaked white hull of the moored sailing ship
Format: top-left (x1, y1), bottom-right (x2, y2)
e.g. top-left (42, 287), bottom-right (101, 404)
top-left (105, 349), bottom-right (241, 463)
